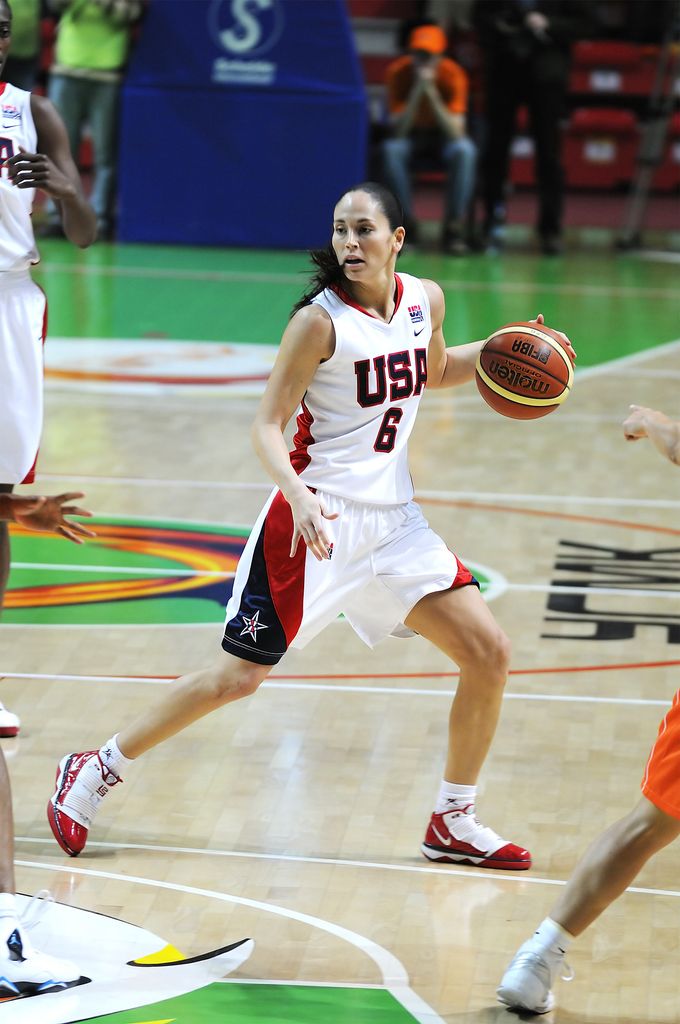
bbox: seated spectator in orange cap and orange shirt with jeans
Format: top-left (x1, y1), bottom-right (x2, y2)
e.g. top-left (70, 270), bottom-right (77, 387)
top-left (382, 25), bottom-right (477, 256)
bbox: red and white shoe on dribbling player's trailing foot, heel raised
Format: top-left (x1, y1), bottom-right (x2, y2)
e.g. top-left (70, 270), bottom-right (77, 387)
top-left (47, 751), bottom-right (123, 857)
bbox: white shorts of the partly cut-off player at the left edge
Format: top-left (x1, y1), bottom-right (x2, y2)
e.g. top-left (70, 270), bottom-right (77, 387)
top-left (0, 270), bottom-right (47, 483)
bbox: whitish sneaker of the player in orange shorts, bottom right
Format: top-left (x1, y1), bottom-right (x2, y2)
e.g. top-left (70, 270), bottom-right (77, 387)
top-left (496, 939), bottom-right (573, 1014)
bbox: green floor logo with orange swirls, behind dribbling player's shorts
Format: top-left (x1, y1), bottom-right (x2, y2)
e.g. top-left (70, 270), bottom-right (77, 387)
top-left (3, 517), bottom-right (504, 626)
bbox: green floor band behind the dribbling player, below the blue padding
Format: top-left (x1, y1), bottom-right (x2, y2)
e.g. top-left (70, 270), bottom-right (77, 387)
top-left (34, 240), bottom-right (680, 367)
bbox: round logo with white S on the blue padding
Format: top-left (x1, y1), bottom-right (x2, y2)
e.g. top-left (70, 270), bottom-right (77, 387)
top-left (208, 0), bottom-right (284, 57)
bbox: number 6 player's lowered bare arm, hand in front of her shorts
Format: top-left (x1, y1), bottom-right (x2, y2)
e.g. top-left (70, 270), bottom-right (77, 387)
top-left (252, 305), bottom-right (335, 560)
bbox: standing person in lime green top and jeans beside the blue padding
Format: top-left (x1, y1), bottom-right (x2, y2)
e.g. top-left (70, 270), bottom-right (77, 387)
top-left (45, 0), bottom-right (143, 241)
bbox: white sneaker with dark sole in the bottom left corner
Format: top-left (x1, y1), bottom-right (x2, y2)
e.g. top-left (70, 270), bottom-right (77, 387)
top-left (0, 918), bottom-right (80, 1001)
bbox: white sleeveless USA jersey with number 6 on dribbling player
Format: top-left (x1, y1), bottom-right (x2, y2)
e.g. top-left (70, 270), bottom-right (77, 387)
top-left (291, 273), bottom-right (432, 505)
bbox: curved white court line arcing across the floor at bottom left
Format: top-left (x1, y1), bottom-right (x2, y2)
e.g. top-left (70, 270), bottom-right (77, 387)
top-left (14, 860), bottom-right (445, 1024)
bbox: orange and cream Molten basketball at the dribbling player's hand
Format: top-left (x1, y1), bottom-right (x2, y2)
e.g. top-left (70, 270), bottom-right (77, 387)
top-left (475, 323), bottom-right (573, 420)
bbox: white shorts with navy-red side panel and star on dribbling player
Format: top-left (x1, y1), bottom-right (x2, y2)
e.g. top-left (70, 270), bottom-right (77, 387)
top-left (222, 489), bottom-right (478, 665)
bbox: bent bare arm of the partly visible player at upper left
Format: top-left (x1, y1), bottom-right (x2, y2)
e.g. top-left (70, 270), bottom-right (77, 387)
top-left (7, 95), bottom-right (96, 249)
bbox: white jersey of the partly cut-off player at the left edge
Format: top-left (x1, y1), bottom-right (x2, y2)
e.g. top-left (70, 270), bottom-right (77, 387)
top-left (0, 82), bottom-right (38, 272)
